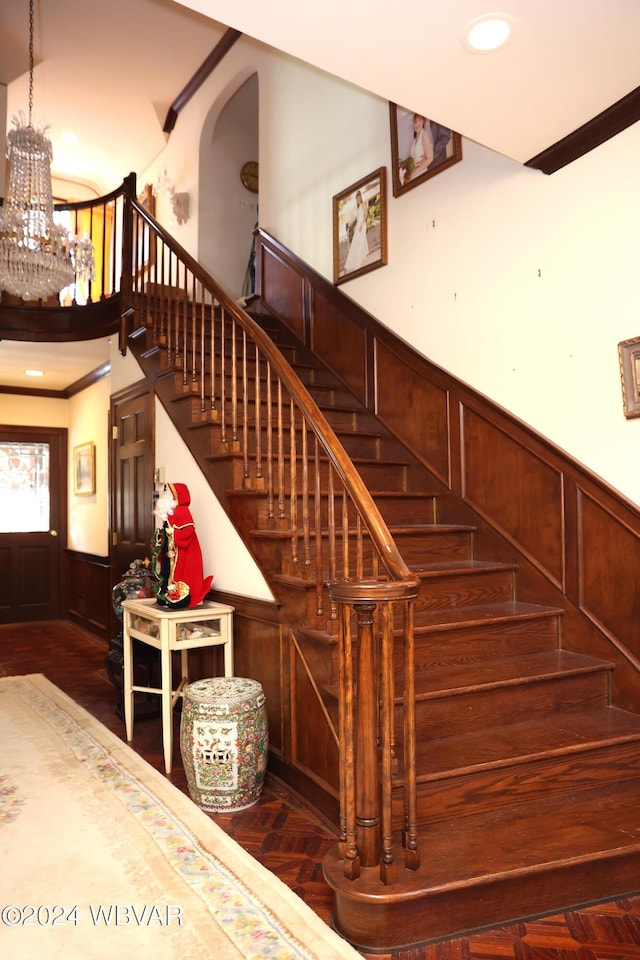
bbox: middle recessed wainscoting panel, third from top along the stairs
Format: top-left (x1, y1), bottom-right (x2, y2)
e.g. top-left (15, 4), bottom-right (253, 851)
top-left (376, 340), bottom-right (451, 486)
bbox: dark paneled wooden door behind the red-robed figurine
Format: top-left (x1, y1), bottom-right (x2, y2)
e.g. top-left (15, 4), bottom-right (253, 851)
top-left (111, 383), bottom-right (155, 583)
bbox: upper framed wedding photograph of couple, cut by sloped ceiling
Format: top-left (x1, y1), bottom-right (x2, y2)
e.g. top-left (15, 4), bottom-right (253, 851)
top-left (389, 103), bottom-right (462, 197)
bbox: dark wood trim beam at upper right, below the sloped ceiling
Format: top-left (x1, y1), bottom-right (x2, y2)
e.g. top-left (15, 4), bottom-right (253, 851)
top-left (525, 87), bottom-right (640, 173)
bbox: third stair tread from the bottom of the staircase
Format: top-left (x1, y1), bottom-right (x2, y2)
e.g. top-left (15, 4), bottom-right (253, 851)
top-left (408, 650), bottom-right (613, 700)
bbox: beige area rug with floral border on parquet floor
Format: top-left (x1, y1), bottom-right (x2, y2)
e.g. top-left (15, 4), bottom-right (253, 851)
top-left (0, 675), bottom-right (360, 960)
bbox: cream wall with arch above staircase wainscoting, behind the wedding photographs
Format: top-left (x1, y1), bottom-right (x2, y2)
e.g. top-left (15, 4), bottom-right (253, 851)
top-left (139, 39), bottom-right (640, 504)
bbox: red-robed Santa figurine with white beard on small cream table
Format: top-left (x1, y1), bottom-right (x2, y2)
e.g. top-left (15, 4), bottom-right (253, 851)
top-left (153, 483), bottom-right (213, 610)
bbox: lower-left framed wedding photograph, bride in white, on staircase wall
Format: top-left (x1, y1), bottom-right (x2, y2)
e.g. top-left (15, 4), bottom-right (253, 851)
top-left (333, 167), bottom-right (387, 284)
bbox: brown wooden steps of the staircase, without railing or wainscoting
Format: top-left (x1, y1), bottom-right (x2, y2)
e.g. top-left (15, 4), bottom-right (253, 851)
top-left (126, 304), bottom-right (640, 951)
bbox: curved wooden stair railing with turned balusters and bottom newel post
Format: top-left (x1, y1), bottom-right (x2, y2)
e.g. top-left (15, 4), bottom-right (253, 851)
top-left (120, 184), bottom-right (419, 884)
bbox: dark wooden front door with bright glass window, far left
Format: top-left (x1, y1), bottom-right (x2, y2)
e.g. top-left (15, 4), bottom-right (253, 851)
top-left (0, 426), bottom-right (67, 623)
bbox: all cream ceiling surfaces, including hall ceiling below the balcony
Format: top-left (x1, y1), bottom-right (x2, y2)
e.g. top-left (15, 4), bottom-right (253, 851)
top-left (0, 0), bottom-right (640, 387)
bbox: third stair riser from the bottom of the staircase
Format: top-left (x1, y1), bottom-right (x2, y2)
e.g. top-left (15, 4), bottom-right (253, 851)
top-left (404, 670), bottom-right (607, 744)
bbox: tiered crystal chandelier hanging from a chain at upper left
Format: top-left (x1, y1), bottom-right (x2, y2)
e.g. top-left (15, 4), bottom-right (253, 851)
top-left (0, 0), bottom-right (93, 300)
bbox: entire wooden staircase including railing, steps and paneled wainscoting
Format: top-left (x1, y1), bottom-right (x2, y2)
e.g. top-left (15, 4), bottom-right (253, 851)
top-left (6, 175), bottom-right (640, 953)
